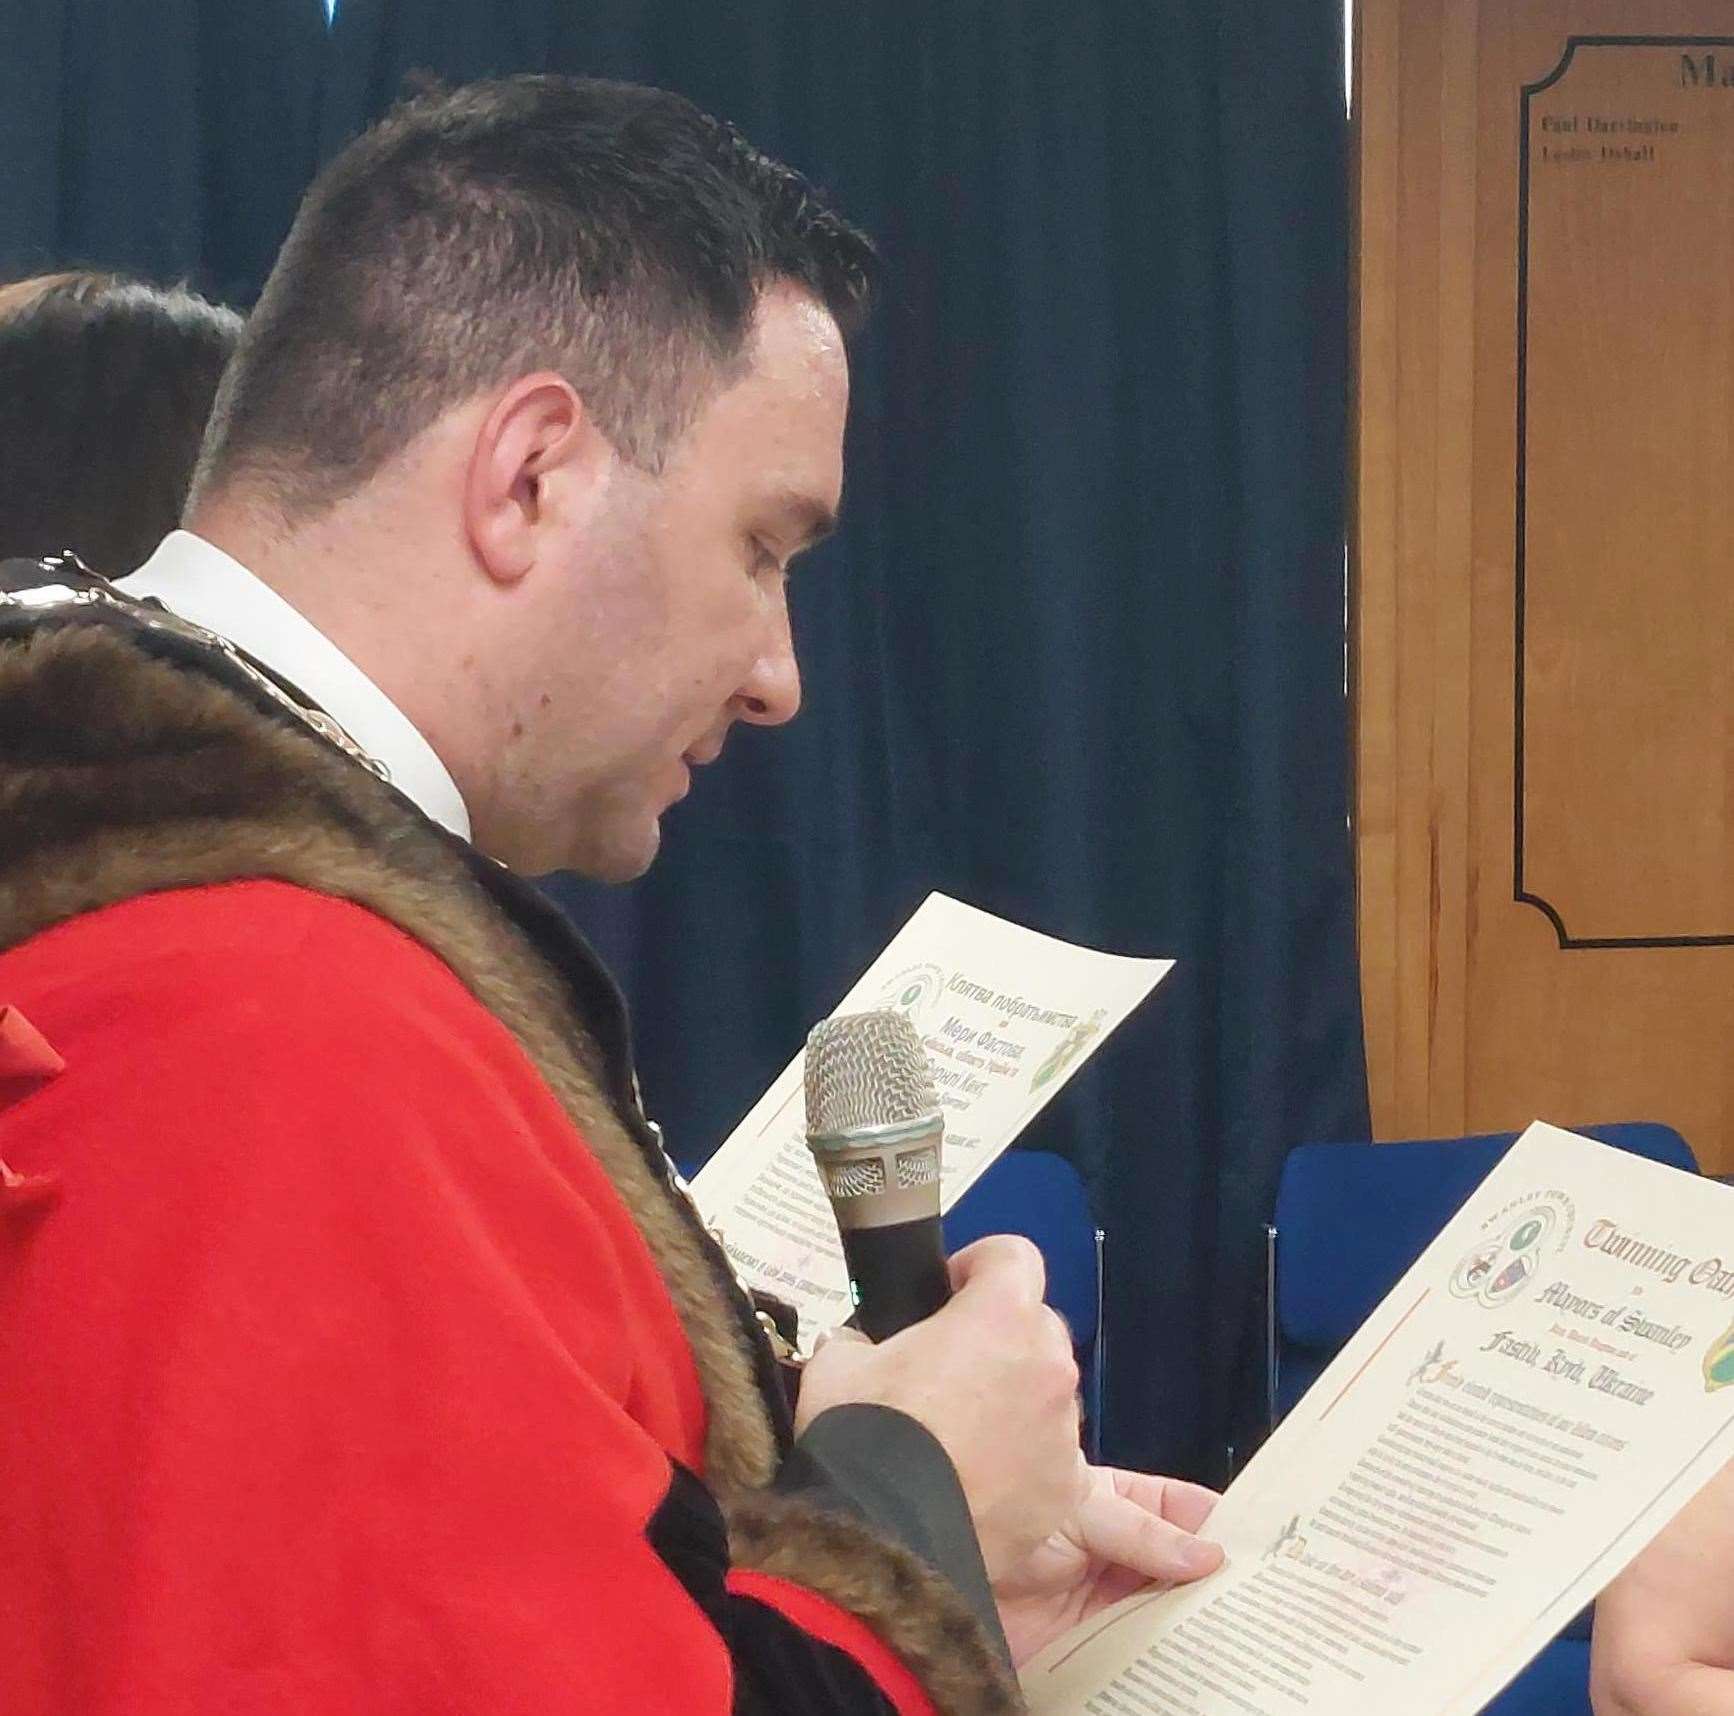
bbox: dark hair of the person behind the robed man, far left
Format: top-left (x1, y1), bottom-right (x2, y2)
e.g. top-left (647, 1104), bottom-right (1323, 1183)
top-left (0, 272), bottom-right (241, 577)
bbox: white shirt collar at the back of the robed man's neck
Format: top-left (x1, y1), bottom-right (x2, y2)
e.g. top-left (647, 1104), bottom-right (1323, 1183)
top-left (116, 530), bottom-right (470, 839)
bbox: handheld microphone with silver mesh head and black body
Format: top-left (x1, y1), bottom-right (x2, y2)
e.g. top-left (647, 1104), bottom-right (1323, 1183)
top-left (806, 1011), bottom-right (952, 1340)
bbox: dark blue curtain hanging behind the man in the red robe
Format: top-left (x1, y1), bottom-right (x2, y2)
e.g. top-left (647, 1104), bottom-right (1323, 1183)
top-left (0, 0), bottom-right (1366, 1479)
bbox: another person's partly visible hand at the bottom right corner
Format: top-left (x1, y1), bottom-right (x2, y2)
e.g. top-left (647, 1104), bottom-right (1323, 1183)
top-left (1590, 1466), bottom-right (1734, 1716)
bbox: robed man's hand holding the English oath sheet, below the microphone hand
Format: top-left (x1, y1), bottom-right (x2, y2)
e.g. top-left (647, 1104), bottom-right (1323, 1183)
top-left (994, 1454), bottom-right (1222, 1664)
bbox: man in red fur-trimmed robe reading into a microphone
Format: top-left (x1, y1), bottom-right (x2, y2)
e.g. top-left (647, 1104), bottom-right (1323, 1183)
top-left (0, 78), bottom-right (1217, 1716)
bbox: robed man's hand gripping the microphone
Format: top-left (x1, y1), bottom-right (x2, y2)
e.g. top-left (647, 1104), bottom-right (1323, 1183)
top-left (796, 1234), bottom-right (1087, 1581)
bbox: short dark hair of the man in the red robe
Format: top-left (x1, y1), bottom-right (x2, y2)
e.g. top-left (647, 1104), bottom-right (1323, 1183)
top-left (194, 76), bottom-right (874, 522)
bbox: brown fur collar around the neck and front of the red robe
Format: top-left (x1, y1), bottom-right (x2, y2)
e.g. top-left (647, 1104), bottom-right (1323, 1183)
top-left (0, 622), bottom-right (777, 1491)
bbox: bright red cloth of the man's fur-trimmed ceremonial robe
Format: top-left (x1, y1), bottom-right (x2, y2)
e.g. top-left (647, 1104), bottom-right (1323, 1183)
top-left (0, 882), bottom-right (933, 1716)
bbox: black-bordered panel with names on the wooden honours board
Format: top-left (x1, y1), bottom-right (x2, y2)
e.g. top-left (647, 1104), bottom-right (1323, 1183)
top-left (1516, 36), bottom-right (1734, 948)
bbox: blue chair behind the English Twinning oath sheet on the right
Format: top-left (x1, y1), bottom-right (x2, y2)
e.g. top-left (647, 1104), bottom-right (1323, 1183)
top-left (1268, 1121), bottom-right (1698, 1716)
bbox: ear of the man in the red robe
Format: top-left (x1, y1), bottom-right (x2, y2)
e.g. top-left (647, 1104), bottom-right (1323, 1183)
top-left (463, 371), bottom-right (614, 584)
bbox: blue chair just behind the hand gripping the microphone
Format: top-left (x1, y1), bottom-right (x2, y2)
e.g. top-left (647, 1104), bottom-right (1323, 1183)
top-left (945, 1149), bottom-right (1105, 1459)
